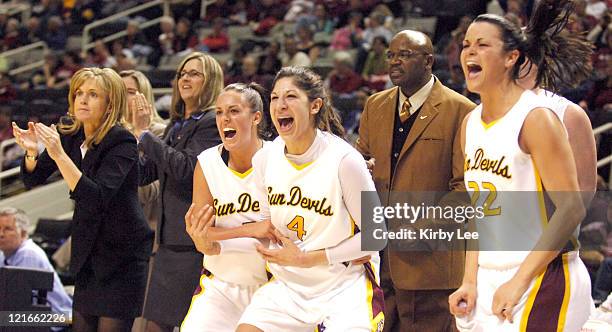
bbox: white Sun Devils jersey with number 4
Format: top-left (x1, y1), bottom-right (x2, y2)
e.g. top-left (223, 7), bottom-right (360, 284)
top-left (262, 133), bottom-right (370, 298)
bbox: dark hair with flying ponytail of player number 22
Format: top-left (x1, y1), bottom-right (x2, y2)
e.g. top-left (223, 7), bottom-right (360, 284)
top-left (474, 0), bottom-right (593, 92)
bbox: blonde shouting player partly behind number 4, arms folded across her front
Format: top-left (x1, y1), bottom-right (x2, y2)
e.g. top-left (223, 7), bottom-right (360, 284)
top-left (181, 83), bottom-right (269, 331)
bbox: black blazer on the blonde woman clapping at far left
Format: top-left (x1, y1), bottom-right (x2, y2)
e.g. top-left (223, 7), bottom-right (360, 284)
top-left (21, 125), bottom-right (153, 279)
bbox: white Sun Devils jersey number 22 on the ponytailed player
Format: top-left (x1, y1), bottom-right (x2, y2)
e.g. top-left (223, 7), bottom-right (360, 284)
top-left (464, 90), bottom-right (549, 269)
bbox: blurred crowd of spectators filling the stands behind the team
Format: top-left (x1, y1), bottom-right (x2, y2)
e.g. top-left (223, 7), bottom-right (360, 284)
top-left (0, 0), bottom-right (612, 318)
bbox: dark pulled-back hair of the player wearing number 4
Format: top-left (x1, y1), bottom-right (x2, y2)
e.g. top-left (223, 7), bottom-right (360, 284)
top-left (272, 67), bottom-right (344, 137)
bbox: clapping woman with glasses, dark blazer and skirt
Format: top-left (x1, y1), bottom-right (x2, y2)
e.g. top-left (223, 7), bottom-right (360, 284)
top-left (134, 52), bottom-right (223, 331)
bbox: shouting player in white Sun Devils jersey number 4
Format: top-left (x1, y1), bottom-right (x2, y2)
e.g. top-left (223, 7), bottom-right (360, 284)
top-left (237, 67), bottom-right (384, 332)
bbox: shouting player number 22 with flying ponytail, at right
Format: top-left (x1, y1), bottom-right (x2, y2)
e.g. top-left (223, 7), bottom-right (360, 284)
top-left (449, 0), bottom-right (592, 331)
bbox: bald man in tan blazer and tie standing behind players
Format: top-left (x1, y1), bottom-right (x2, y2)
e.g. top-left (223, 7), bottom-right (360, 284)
top-left (357, 30), bottom-right (476, 332)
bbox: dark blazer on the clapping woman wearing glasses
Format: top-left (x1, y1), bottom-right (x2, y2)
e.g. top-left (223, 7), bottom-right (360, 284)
top-left (138, 110), bottom-right (221, 250)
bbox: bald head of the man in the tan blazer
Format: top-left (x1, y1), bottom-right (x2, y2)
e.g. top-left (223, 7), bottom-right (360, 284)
top-left (387, 30), bottom-right (433, 96)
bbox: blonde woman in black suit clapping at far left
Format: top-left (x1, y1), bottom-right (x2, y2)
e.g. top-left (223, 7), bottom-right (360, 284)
top-left (13, 68), bottom-right (152, 331)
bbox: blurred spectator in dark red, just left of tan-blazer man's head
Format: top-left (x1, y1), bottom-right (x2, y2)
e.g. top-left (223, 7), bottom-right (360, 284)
top-left (327, 51), bottom-right (363, 94)
